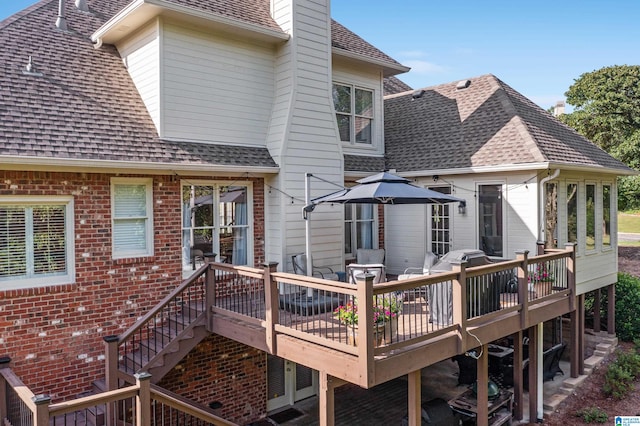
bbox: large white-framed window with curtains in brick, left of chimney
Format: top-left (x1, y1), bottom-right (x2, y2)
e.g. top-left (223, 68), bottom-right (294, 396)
top-left (182, 183), bottom-right (253, 270)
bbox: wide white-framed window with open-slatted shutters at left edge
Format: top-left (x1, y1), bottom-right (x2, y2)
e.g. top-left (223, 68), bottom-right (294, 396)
top-left (0, 197), bottom-right (75, 290)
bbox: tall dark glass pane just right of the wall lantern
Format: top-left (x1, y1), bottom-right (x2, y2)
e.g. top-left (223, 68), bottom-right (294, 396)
top-left (478, 185), bottom-right (502, 256)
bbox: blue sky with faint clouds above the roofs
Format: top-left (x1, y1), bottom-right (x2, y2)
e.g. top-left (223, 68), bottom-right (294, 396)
top-left (0, 0), bottom-right (640, 110)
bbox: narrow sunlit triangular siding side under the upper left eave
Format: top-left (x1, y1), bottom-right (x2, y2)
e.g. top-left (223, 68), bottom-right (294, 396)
top-left (118, 20), bottom-right (161, 133)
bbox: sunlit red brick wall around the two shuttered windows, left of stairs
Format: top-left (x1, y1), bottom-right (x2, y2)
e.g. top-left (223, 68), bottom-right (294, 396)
top-left (0, 171), bottom-right (264, 416)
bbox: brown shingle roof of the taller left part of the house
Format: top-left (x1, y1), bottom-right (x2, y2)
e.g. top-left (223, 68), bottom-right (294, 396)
top-left (0, 0), bottom-right (395, 168)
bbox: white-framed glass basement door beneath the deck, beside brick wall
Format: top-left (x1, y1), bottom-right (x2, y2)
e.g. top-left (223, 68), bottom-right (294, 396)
top-left (267, 355), bottom-right (318, 411)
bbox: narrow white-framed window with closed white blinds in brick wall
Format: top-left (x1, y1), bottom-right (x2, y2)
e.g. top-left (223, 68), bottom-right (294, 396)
top-left (111, 178), bottom-right (153, 259)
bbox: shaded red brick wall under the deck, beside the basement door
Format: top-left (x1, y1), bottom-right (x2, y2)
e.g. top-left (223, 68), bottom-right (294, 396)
top-left (159, 335), bottom-right (267, 424)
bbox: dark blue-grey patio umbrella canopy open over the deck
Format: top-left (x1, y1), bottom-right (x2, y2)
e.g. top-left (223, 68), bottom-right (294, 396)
top-left (311, 172), bottom-right (464, 204)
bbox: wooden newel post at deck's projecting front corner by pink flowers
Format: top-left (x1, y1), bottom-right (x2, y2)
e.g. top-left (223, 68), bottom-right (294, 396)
top-left (356, 273), bottom-right (375, 387)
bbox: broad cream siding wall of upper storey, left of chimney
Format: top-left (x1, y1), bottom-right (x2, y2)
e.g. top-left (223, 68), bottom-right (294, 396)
top-left (161, 23), bottom-right (274, 146)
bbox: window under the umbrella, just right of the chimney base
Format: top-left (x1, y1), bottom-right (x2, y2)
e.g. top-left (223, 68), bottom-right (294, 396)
top-left (344, 204), bottom-right (378, 258)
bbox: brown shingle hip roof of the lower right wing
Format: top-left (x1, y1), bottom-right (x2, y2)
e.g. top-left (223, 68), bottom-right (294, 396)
top-left (385, 74), bottom-right (630, 173)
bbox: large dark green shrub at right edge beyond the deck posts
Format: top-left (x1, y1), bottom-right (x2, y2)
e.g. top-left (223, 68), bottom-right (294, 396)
top-left (616, 273), bottom-right (640, 342)
